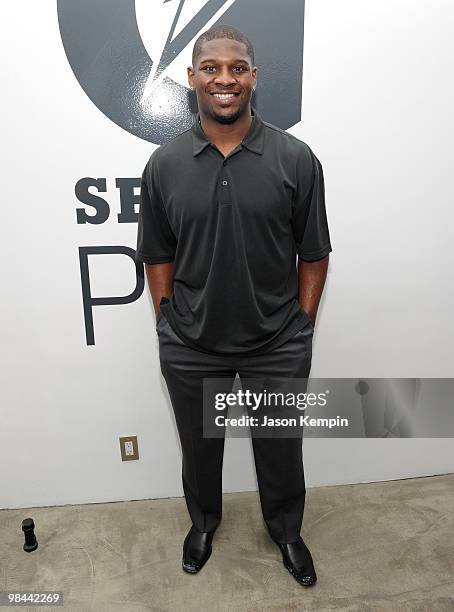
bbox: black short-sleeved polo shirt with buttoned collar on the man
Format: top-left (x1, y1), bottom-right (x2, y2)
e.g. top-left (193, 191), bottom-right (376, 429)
top-left (136, 108), bottom-right (332, 356)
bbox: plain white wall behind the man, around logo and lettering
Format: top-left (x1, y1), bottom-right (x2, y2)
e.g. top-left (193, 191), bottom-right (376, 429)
top-left (0, 0), bottom-right (454, 507)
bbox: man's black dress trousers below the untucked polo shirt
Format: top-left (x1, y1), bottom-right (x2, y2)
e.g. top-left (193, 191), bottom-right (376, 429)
top-left (156, 314), bottom-right (314, 543)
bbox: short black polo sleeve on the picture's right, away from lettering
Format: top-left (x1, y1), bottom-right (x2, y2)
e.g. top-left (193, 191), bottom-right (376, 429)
top-left (292, 145), bottom-right (332, 261)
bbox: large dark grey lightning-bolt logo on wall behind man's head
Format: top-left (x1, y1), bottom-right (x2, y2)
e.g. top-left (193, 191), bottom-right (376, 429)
top-left (57, 0), bottom-right (304, 144)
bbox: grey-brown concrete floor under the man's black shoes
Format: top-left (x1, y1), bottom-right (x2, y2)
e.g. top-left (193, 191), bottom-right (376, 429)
top-left (0, 474), bottom-right (454, 612)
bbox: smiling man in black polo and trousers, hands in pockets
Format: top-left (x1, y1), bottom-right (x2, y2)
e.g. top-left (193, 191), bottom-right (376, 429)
top-left (137, 26), bottom-right (332, 586)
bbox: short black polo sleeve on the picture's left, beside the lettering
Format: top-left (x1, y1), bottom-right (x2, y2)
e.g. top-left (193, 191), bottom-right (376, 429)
top-left (136, 152), bottom-right (177, 264)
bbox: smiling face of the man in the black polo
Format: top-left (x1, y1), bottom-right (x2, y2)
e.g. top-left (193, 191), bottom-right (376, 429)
top-left (188, 38), bottom-right (257, 123)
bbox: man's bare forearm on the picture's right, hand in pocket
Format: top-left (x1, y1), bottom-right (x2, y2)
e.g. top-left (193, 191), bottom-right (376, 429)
top-left (298, 255), bottom-right (329, 324)
